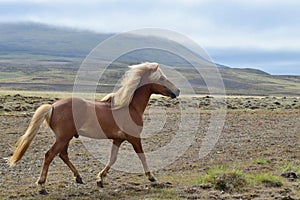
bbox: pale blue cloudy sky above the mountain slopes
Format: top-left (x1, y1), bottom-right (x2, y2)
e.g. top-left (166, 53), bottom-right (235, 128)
top-left (0, 0), bottom-right (300, 75)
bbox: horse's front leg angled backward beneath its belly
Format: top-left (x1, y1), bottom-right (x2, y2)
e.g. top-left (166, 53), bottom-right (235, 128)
top-left (97, 139), bottom-right (124, 188)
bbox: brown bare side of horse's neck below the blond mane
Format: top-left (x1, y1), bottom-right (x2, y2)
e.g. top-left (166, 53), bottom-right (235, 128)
top-left (130, 84), bottom-right (152, 115)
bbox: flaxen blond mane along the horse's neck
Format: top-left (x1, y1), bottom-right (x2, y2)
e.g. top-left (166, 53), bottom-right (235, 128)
top-left (101, 62), bottom-right (162, 109)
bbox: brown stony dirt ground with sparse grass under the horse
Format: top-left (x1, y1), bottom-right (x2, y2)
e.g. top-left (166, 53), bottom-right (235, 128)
top-left (0, 95), bottom-right (300, 199)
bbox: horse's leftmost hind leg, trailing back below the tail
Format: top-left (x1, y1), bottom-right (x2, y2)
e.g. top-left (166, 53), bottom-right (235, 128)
top-left (37, 140), bottom-right (69, 195)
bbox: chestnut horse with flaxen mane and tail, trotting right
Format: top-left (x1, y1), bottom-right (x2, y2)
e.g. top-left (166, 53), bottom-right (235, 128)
top-left (8, 62), bottom-right (180, 195)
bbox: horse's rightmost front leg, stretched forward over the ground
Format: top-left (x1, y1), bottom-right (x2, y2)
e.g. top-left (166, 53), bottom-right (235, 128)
top-left (129, 138), bottom-right (156, 182)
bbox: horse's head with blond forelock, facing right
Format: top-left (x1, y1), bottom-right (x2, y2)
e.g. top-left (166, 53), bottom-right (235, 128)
top-left (144, 63), bottom-right (180, 98)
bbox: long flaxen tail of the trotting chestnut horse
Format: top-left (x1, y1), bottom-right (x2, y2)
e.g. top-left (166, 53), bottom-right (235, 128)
top-left (8, 104), bottom-right (52, 166)
